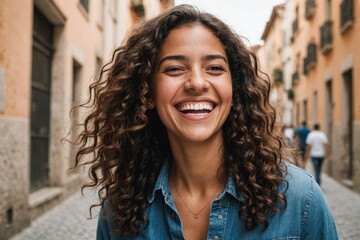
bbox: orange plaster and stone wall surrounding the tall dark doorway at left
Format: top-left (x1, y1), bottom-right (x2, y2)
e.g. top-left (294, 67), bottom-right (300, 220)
top-left (0, 0), bottom-right (173, 240)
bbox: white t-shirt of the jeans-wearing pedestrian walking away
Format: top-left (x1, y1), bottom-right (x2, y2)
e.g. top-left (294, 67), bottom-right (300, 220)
top-left (306, 130), bottom-right (328, 157)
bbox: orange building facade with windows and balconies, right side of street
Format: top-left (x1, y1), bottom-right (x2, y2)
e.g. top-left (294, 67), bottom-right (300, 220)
top-left (263, 0), bottom-right (360, 192)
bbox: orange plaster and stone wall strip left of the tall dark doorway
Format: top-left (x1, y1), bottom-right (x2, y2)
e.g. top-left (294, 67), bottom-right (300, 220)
top-left (0, 0), bottom-right (32, 239)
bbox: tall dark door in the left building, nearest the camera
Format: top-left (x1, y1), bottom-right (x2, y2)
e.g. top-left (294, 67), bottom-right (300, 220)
top-left (30, 7), bottom-right (54, 191)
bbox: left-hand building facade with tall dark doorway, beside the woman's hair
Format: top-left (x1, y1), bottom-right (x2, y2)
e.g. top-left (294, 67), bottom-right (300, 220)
top-left (0, 0), bottom-right (173, 239)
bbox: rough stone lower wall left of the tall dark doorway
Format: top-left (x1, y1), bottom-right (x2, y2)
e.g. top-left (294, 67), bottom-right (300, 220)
top-left (0, 117), bottom-right (30, 239)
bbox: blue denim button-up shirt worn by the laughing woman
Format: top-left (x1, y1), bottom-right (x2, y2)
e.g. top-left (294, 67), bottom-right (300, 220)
top-left (97, 162), bottom-right (338, 240)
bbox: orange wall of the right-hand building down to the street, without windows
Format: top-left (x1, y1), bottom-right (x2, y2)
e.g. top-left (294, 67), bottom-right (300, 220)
top-left (292, 0), bottom-right (360, 191)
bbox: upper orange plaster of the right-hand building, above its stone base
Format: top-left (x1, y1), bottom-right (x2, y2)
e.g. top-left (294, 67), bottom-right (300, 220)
top-left (292, 0), bottom-right (360, 126)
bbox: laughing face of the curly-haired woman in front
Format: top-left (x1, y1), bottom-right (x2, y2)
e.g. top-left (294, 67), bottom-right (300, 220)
top-left (153, 24), bottom-right (232, 143)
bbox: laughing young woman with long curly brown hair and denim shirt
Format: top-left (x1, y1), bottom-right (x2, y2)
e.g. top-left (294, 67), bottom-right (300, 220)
top-left (76, 5), bottom-right (337, 239)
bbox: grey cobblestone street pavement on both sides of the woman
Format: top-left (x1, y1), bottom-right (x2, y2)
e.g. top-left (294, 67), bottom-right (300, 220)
top-left (11, 169), bottom-right (360, 240)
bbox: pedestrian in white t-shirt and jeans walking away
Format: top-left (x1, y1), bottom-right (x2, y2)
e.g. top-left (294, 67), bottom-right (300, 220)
top-left (305, 123), bottom-right (331, 185)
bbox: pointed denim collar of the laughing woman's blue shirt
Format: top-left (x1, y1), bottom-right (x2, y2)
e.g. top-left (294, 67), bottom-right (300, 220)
top-left (147, 159), bottom-right (241, 203)
